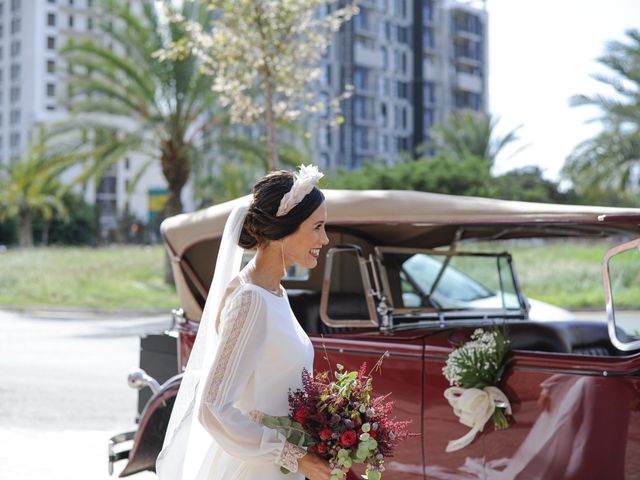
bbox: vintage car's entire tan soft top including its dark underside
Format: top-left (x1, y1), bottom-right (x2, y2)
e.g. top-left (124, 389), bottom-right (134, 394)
top-left (161, 190), bottom-right (640, 320)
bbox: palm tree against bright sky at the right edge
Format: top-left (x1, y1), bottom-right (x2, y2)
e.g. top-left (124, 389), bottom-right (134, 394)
top-left (562, 29), bottom-right (640, 192)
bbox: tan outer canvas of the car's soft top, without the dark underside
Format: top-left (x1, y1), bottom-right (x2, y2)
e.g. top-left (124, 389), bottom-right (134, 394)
top-left (162, 190), bottom-right (640, 256)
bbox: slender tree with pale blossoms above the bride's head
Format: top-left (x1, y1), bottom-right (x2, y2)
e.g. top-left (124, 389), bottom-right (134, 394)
top-left (158, 0), bottom-right (358, 170)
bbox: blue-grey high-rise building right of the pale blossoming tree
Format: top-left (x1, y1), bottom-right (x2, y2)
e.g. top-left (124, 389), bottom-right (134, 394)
top-left (315, 0), bottom-right (488, 169)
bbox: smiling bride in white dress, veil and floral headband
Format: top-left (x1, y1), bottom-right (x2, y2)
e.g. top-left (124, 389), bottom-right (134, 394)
top-left (156, 165), bottom-right (331, 480)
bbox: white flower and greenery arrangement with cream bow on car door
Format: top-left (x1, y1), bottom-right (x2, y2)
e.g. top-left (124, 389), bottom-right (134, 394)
top-left (442, 327), bottom-right (511, 452)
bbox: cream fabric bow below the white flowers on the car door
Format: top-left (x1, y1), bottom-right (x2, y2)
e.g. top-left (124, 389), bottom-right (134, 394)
top-left (444, 387), bottom-right (511, 452)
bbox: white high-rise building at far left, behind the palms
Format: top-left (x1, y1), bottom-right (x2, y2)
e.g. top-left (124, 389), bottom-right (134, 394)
top-left (0, 0), bottom-right (188, 238)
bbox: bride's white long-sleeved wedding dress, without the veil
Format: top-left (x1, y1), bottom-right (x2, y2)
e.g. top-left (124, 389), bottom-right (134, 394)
top-left (198, 272), bottom-right (313, 480)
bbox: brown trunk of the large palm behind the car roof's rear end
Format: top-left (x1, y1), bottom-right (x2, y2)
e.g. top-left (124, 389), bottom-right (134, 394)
top-left (160, 139), bottom-right (191, 285)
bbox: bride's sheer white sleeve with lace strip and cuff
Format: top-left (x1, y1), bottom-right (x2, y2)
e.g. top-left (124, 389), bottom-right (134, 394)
top-left (198, 288), bottom-right (306, 471)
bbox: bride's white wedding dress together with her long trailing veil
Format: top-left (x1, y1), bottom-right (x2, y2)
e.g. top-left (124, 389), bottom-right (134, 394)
top-left (156, 203), bottom-right (313, 480)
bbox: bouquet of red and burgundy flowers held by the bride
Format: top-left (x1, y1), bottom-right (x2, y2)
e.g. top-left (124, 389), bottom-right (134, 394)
top-left (262, 364), bottom-right (409, 480)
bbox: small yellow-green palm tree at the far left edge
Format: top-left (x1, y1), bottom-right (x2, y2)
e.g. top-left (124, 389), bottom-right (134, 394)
top-left (0, 131), bottom-right (77, 247)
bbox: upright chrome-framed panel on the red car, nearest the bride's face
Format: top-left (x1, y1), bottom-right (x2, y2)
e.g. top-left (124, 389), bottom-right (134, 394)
top-left (320, 245), bottom-right (379, 328)
